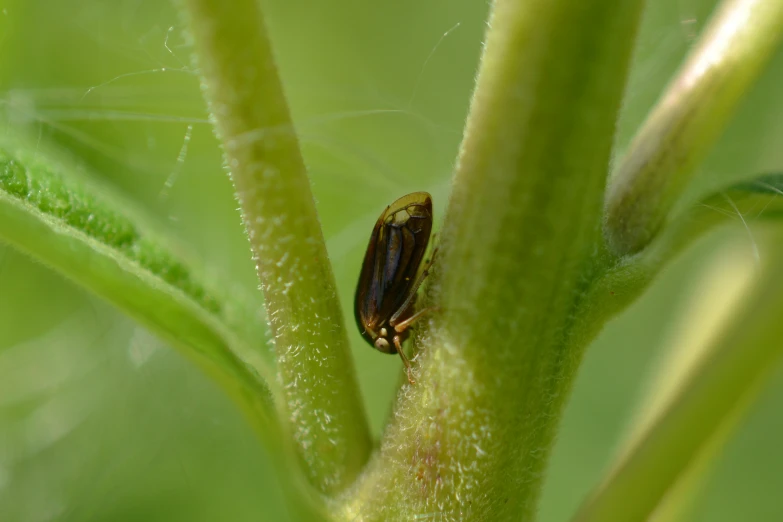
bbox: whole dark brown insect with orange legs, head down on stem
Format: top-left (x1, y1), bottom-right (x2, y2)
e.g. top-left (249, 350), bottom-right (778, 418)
top-left (354, 192), bottom-right (434, 384)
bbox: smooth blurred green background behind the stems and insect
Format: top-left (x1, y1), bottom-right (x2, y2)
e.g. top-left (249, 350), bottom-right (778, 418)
top-left (0, 0), bottom-right (783, 522)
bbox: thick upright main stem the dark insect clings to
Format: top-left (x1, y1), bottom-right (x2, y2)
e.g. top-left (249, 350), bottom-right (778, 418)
top-left (344, 0), bottom-right (642, 520)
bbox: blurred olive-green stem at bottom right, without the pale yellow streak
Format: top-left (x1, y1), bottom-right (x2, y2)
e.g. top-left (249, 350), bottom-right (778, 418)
top-left (576, 234), bottom-right (783, 522)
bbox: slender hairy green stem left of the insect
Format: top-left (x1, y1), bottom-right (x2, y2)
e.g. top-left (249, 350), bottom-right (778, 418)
top-left (184, 0), bottom-right (371, 493)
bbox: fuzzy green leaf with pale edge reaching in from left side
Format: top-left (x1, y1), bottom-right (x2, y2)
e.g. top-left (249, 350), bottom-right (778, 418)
top-left (0, 134), bottom-right (280, 444)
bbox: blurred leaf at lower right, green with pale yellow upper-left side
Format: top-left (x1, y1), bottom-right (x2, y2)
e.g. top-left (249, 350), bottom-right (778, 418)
top-left (575, 234), bottom-right (783, 522)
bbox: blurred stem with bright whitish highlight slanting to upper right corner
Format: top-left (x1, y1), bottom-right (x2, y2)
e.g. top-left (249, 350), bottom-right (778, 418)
top-left (606, 0), bottom-right (783, 255)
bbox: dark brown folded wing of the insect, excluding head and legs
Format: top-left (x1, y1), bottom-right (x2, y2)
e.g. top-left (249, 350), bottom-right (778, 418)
top-left (354, 192), bottom-right (432, 343)
